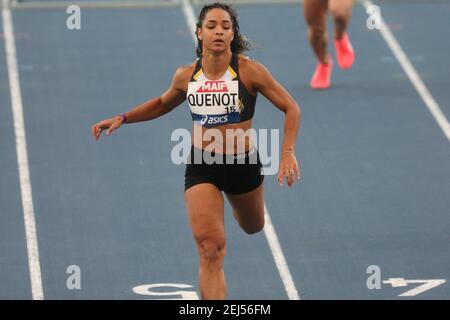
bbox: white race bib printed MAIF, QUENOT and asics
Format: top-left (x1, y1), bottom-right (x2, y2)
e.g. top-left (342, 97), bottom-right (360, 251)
top-left (187, 80), bottom-right (241, 127)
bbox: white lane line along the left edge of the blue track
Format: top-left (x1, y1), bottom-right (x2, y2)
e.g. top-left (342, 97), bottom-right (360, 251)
top-left (2, 0), bottom-right (44, 300)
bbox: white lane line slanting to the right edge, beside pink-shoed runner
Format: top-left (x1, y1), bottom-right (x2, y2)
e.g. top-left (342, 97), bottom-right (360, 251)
top-left (360, 0), bottom-right (450, 142)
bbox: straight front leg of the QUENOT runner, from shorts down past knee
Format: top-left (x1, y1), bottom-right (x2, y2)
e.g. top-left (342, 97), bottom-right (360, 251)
top-left (184, 183), bottom-right (227, 299)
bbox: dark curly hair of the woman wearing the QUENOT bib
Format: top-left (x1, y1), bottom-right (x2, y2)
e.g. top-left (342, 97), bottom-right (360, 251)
top-left (195, 2), bottom-right (251, 57)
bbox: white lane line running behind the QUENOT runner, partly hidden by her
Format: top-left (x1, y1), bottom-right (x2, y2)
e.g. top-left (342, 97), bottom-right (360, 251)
top-left (181, 0), bottom-right (300, 300)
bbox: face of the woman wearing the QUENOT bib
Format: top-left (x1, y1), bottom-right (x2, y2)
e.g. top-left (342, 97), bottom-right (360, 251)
top-left (197, 8), bottom-right (234, 53)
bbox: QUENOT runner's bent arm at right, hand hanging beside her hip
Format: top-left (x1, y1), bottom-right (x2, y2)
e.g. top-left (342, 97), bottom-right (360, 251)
top-left (249, 61), bottom-right (302, 186)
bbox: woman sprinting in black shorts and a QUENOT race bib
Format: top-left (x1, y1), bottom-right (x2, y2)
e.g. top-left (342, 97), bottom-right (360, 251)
top-left (92, 3), bottom-right (301, 299)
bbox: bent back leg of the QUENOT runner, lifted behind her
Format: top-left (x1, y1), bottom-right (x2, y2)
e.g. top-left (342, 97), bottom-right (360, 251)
top-left (226, 184), bottom-right (264, 234)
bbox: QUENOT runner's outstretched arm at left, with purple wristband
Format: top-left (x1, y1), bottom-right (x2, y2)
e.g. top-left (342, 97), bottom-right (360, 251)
top-left (92, 67), bottom-right (190, 140)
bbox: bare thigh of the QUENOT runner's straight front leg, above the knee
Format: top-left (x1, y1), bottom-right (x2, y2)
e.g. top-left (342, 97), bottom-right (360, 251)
top-left (184, 183), bottom-right (225, 242)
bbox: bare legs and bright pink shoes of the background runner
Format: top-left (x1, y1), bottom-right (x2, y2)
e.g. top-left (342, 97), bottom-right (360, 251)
top-left (303, 0), bottom-right (355, 89)
